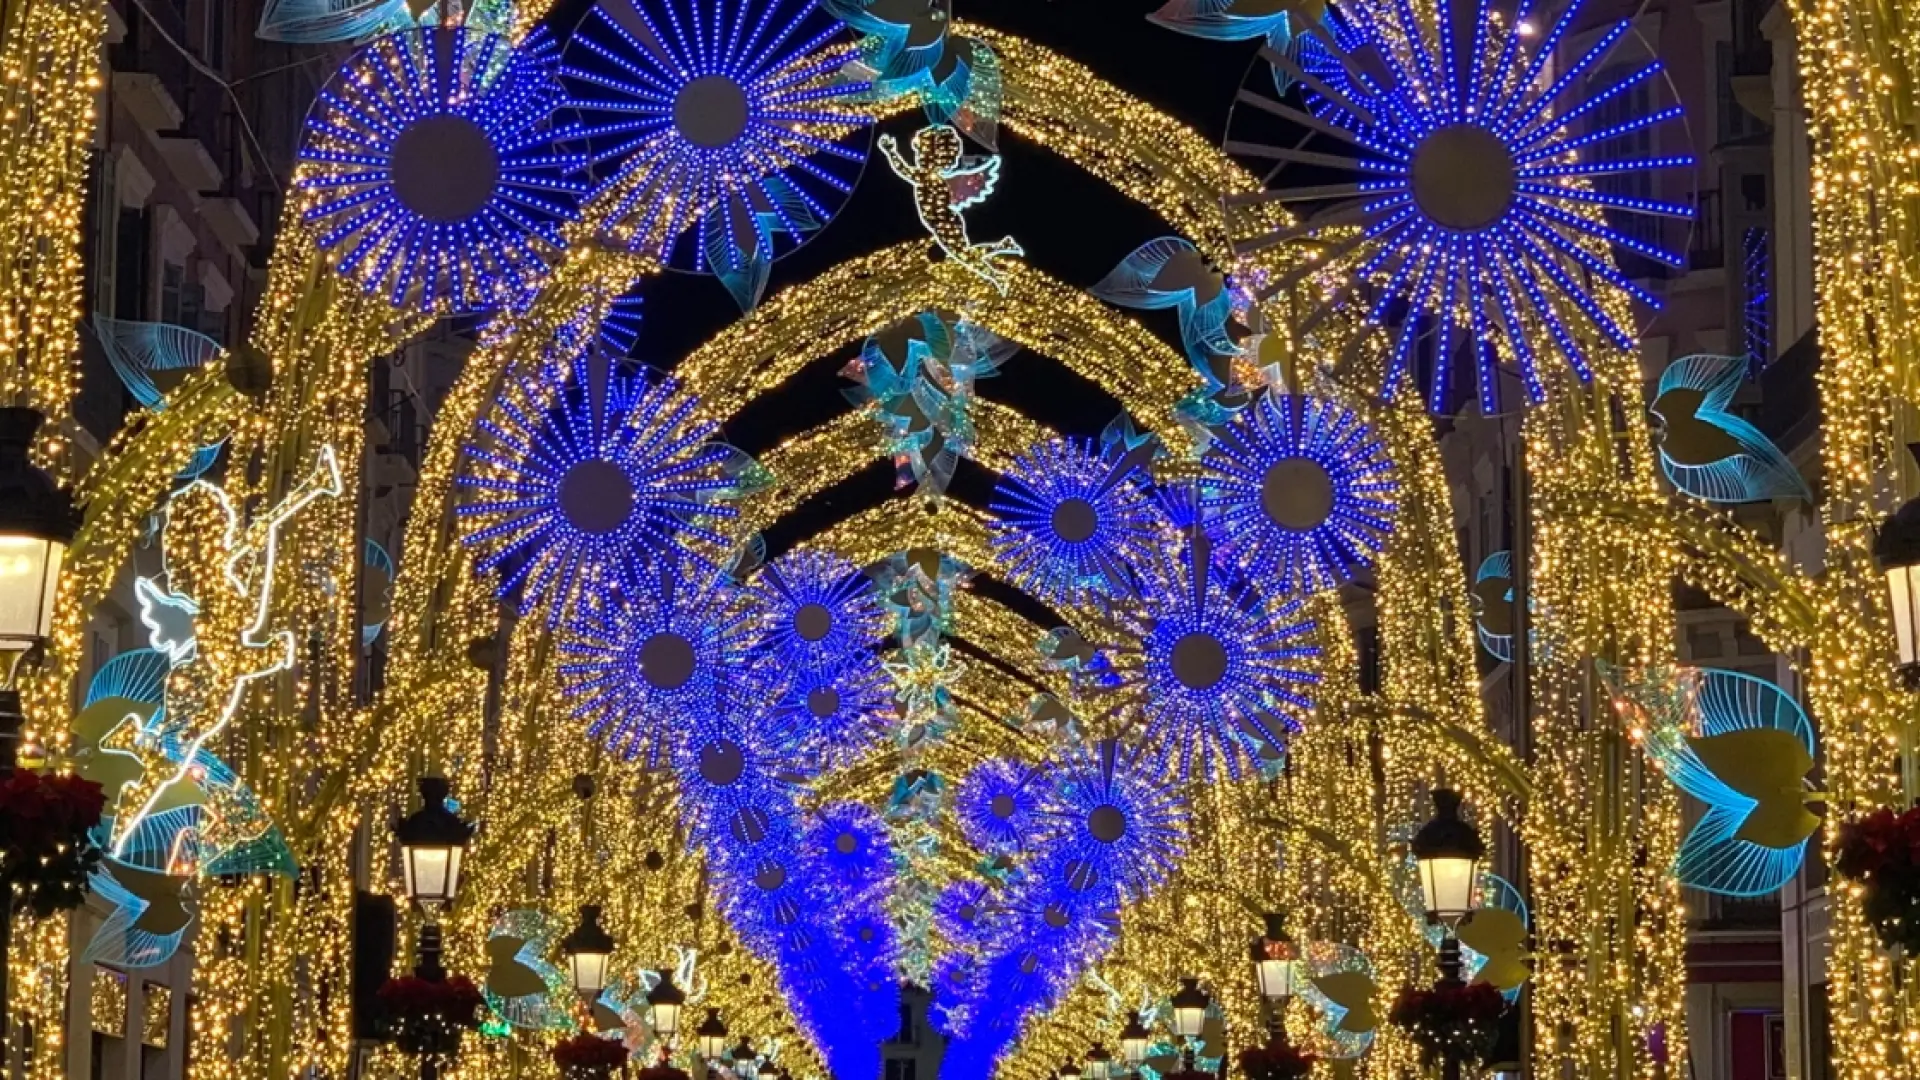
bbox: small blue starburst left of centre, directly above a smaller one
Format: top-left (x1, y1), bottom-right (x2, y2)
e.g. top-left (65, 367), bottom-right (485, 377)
top-left (756, 548), bottom-right (887, 675)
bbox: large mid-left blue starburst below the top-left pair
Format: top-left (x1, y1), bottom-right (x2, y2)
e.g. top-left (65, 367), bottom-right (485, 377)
top-left (459, 356), bottom-right (758, 621)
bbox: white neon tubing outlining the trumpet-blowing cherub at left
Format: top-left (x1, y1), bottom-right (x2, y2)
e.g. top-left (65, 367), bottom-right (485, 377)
top-left (113, 446), bottom-right (342, 857)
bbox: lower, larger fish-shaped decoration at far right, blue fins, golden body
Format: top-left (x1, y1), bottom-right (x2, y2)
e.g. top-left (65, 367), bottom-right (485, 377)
top-left (1601, 669), bottom-right (1822, 897)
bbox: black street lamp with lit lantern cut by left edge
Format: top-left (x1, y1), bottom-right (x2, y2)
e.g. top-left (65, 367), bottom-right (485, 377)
top-left (0, 407), bottom-right (81, 1074)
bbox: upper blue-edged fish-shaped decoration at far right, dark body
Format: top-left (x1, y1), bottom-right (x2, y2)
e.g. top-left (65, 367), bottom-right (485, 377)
top-left (1647, 354), bottom-right (1812, 503)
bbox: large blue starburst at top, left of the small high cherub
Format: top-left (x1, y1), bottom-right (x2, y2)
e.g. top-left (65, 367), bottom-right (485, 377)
top-left (564, 0), bottom-right (872, 290)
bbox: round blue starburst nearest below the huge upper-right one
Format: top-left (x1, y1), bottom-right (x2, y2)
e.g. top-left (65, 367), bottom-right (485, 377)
top-left (1200, 394), bottom-right (1394, 592)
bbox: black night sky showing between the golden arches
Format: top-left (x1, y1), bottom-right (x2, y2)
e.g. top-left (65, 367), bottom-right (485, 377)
top-left (533, 0), bottom-right (1254, 552)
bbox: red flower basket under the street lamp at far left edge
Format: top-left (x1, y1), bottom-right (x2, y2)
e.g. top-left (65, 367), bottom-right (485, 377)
top-left (0, 771), bottom-right (106, 919)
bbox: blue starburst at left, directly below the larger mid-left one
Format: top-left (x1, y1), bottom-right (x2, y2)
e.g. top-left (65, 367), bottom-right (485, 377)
top-left (559, 565), bottom-right (764, 765)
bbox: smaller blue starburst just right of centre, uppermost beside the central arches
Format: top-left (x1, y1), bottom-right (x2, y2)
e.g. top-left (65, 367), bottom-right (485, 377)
top-left (993, 438), bottom-right (1156, 603)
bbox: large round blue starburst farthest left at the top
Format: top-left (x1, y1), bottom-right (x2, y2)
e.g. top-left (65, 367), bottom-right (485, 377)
top-left (298, 27), bottom-right (586, 311)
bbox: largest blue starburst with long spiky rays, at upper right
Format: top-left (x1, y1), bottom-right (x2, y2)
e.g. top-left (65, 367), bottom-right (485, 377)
top-left (1227, 0), bottom-right (1693, 411)
